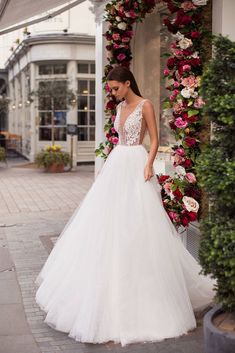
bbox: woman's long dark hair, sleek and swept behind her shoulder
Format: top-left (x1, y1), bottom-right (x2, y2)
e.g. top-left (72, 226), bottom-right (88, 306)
top-left (107, 66), bottom-right (142, 97)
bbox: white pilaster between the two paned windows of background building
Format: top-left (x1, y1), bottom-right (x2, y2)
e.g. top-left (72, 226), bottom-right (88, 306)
top-left (67, 60), bottom-right (78, 169)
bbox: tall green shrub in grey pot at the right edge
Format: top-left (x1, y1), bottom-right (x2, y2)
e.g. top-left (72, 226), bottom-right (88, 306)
top-left (196, 36), bottom-right (235, 353)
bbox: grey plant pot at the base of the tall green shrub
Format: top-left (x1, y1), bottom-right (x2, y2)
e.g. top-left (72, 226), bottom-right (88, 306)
top-left (203, 305), bottom-right (235, 353)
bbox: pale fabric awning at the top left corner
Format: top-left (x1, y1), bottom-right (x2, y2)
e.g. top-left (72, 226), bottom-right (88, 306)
top-left (0, 0), bottom-right (84, 34)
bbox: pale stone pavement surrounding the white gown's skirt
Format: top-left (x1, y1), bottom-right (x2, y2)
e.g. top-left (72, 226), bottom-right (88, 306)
top-left (0, 160), bottom-right (206, 353)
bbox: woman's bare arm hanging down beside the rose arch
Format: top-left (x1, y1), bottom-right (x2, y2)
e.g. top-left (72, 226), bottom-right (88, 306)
top-left (143, 100), bottom-right (159, 181)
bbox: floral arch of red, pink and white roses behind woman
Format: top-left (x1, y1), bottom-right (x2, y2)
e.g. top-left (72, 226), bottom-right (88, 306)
top-left (96, 0), bottom-right (208, 227)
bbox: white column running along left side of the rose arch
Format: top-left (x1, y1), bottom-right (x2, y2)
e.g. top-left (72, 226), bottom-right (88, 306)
top-left (95, 21), bottom-right (106, 177)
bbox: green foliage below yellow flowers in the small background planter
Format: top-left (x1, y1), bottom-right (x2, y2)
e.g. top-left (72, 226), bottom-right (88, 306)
top-left (35, 150), bottom-right (70, 168)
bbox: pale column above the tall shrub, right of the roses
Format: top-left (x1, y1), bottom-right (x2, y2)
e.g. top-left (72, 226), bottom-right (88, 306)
top-left (212, 0), bottom-right (235, 40)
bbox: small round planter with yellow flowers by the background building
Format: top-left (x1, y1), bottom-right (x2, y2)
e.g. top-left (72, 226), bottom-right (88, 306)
top-left (35, 145), bottom-right (70, 173)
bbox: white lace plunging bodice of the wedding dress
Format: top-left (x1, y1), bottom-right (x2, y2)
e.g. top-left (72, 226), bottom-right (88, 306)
top-left (114, 99), bottom-right (146, 146)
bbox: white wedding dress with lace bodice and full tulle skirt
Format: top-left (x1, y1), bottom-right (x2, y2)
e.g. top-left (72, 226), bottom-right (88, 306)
top-left (36, 100), bottom-right (214, 346)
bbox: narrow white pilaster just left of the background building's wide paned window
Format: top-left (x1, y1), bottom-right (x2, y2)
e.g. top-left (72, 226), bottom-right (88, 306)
top-left (29, 63), bottom-right (36, 162)
